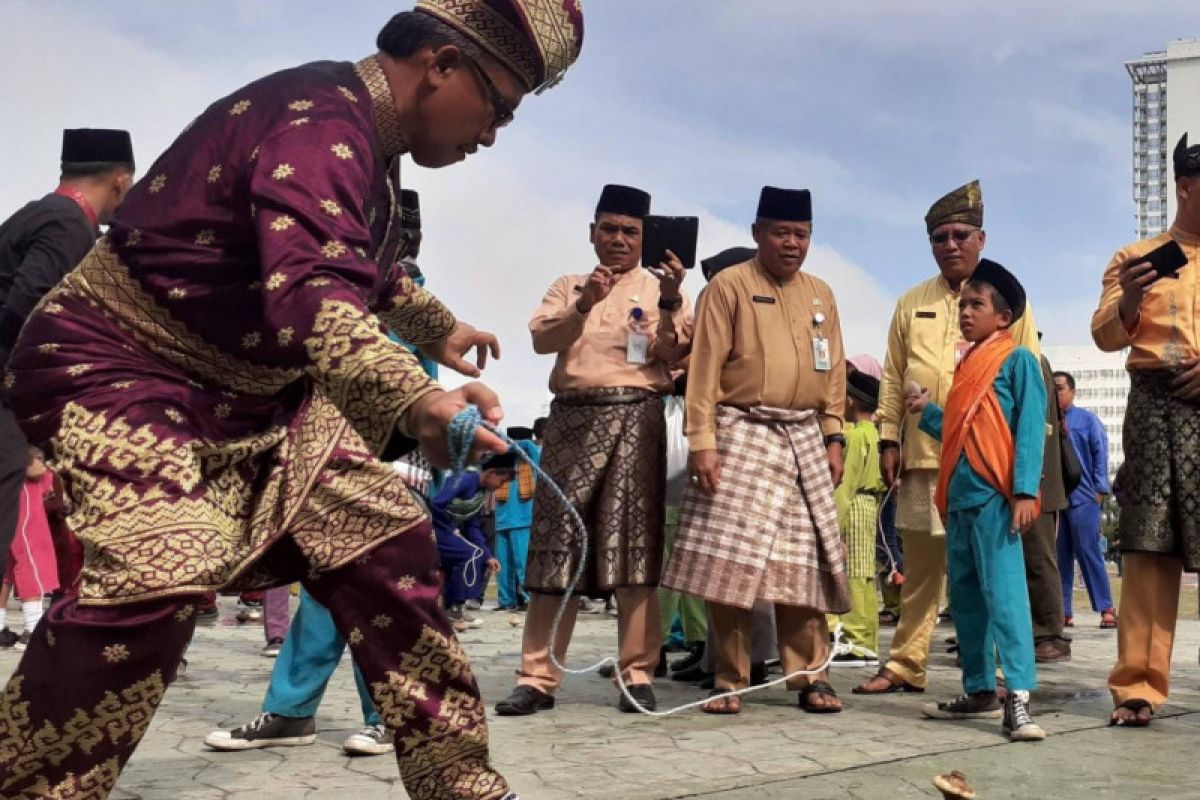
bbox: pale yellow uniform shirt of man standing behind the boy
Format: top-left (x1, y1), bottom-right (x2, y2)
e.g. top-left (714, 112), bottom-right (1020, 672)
top-left (878, 275), bottom-right (1042, 469)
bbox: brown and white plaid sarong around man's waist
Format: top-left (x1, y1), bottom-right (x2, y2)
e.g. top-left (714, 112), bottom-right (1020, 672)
top-left (662, 405), bottom-right (850, 614)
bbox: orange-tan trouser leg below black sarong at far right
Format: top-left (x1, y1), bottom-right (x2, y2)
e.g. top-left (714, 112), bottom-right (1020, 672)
top-left (1109, 552), bottom-right (1183, 711)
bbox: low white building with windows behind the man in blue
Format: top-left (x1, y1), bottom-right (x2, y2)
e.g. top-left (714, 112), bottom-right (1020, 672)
top-left (1042, 345), bottom-right (1129, 477)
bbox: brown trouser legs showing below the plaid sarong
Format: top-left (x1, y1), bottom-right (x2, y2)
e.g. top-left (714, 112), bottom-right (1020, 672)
top-left (708, 602), bottom-right (829, 690)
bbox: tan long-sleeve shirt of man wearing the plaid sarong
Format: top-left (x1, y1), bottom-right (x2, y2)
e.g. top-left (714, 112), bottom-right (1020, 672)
top-left (686, 259), bottom-right (846, 451)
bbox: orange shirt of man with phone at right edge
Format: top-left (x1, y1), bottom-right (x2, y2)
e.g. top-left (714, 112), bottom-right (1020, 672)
top-left (1092, 227), bottom-right (1200, 369)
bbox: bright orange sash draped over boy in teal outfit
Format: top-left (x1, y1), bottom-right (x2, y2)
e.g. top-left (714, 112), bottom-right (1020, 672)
top-left (934, 329), bottom-right (1042, 522)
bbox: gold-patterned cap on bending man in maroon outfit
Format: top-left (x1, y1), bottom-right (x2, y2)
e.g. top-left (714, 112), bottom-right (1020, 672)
top-left (415, 0), bottom-right (583, 95)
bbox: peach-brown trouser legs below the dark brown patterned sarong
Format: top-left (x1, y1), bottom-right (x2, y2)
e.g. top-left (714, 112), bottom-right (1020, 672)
top-left (517, 587), bottom-right (662, 694)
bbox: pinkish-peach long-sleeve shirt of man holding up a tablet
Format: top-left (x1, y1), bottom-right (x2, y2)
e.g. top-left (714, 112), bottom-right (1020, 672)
top-left (529, 267), bottom-right (691, 395)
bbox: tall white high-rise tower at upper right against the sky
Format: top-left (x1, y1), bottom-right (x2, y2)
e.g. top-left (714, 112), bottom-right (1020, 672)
top-left (1126, 38), bottom-right (1200, 239)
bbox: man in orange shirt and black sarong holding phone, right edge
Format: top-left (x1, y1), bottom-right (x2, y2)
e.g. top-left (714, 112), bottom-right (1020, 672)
top-left (1092, 133), bottom-right (1200, 727)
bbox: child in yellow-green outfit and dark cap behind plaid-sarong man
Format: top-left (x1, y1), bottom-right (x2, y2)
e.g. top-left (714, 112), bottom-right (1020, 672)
top-left (833, 372), bottom-right (884, 667)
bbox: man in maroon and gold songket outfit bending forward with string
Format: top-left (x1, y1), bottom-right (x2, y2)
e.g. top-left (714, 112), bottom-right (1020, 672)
top-left (0, 0), bottom-right (583, 800)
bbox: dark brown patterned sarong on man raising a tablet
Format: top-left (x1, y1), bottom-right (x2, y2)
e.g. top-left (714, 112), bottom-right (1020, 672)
top-left (526, 389), bottom-right (666, 594)
